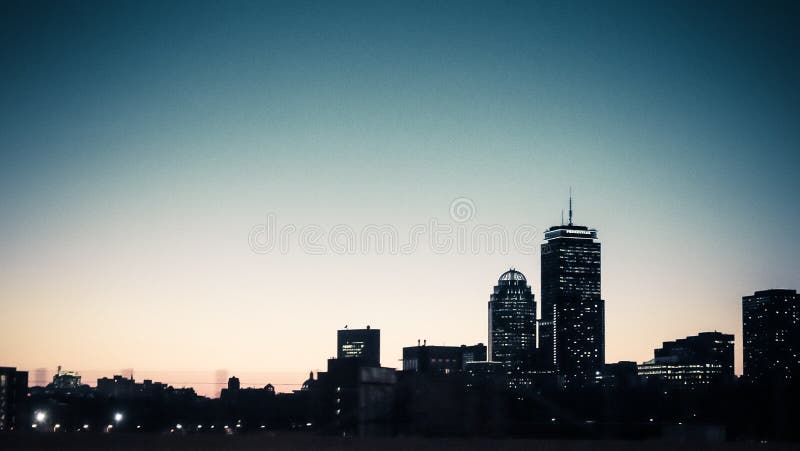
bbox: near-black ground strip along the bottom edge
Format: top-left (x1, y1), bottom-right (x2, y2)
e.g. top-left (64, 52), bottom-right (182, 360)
top-left (0, 434), bottom-right (798, 451)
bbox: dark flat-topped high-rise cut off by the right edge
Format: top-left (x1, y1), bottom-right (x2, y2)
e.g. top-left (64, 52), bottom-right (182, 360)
top-left (742, 290), bottom-right (800, 383)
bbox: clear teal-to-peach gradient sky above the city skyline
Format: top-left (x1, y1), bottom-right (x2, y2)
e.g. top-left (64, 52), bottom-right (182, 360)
top-left (0, 1), bottom-right (800, 394)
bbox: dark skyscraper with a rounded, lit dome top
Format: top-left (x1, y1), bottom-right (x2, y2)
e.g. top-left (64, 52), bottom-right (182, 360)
top-left (489, 269), bottom-right (536, 367)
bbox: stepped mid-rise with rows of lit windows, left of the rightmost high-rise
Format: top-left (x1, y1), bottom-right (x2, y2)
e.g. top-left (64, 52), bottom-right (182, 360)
top-left (638, 332), bottom-right (734, 387)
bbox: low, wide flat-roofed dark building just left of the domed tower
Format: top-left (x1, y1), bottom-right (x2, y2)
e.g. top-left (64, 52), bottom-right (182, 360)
top-left (403, 343), bottom-right (486, 374)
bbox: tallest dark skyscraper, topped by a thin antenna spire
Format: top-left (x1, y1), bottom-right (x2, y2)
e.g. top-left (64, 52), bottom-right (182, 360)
top-left (539, 195), bottom-right (605, 388)
